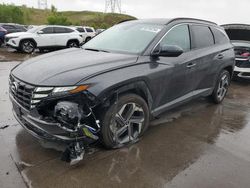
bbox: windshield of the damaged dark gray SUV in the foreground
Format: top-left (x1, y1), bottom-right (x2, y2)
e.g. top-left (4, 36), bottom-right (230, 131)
top-left (83, 23), bottom-right (164, 54)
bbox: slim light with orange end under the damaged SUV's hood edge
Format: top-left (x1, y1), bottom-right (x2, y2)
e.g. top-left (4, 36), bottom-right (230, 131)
top-left (52, 85), bottom-right (89, 95)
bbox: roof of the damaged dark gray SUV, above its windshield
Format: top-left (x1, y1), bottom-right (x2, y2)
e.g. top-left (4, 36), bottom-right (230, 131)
top-left (120, 18), bottom-right (218, 26)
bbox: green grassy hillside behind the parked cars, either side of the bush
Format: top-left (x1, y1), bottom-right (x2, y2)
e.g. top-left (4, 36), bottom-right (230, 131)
top-left (21, 7), bottom-right (135, 28)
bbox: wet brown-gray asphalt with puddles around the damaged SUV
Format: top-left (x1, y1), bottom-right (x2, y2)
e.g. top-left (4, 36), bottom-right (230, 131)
top-left (0, 49), bottom-right (250, 188)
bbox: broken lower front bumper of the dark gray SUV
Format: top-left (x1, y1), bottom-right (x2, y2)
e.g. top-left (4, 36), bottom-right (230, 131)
top-left (10, 92), bottom-right (98, 144)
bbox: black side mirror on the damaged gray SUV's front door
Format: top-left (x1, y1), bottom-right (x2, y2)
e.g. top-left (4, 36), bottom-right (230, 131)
top-left (152, 45), bottom-right (184, 57)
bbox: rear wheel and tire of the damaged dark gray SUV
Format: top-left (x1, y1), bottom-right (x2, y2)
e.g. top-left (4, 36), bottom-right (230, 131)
top-left (210, 70), bottom-right (230, 104)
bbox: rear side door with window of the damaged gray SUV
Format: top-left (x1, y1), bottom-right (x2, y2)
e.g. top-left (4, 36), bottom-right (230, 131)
top-left (190, 24), bottom-right (220, 94)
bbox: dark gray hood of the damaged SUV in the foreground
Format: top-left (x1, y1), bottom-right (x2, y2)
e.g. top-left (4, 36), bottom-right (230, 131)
top-left (11, 48), bottom-right (138, 86)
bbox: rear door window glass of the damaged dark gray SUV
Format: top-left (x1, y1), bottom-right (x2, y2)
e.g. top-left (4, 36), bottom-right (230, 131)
top-left (191, 25), bottom-right (214, 48)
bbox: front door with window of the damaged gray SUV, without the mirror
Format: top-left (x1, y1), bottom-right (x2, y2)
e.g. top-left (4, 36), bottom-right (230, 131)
top-left (154, 24), bottom-right (196, 106)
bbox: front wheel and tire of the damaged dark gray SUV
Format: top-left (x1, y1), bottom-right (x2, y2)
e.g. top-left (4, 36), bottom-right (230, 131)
top-left (101, 94), bottom-right (149, 149)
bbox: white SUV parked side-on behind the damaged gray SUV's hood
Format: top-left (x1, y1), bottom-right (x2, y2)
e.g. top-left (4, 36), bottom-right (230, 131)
top-left (5, 25), bottom-right (83, 53)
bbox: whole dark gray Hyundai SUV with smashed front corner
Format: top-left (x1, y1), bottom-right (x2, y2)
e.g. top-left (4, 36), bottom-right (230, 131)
top-left (10, 18), bottom-right (235, 163)
